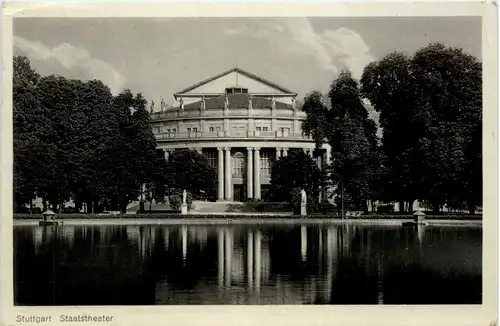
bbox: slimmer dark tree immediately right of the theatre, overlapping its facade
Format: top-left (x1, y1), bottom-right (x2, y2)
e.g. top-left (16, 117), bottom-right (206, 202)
top-left (304, 71), bottom-right (380, 211)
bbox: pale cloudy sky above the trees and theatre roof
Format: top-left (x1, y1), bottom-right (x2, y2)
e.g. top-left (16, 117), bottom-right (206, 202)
top-left (13, 17), bottom-right (481, 105)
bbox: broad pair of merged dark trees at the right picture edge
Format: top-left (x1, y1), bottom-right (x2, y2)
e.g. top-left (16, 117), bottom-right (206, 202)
top-left (361, 44), bottom-right (482, 214)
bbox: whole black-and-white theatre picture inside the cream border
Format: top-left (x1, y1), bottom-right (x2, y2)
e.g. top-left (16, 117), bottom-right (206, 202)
top-left (2, 1), bottom-right (497, 324)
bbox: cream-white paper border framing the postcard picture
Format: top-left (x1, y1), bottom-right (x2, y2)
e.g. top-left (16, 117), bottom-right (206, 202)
top-left (0, 1), bottom-right (498, 326)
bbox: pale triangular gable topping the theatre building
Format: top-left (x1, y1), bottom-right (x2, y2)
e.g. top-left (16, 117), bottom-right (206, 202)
top-left (174, 67), bottom-right (297, 97)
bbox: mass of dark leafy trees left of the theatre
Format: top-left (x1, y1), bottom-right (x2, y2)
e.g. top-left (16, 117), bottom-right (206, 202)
top-left (13, 56), bottom-right (216, 212)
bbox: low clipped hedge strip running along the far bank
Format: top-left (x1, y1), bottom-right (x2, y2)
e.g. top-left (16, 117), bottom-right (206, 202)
top-left (14, 213), bottom-right (483, 220)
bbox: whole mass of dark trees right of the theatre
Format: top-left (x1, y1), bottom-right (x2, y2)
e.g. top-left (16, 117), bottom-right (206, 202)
top-left (303, 43), bottom-right (482, 213)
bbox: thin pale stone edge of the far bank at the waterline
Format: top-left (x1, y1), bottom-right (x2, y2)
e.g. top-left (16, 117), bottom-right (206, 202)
top-left (12, 217), bottom-right (483, 227)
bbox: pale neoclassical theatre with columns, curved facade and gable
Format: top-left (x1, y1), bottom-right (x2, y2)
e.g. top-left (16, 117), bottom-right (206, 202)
top-left (151, 68), bottom-right (330, 201)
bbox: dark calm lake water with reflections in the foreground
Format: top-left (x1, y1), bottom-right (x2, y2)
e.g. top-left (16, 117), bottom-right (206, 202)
top-left (14, 224), bottom-right (482, 305)
